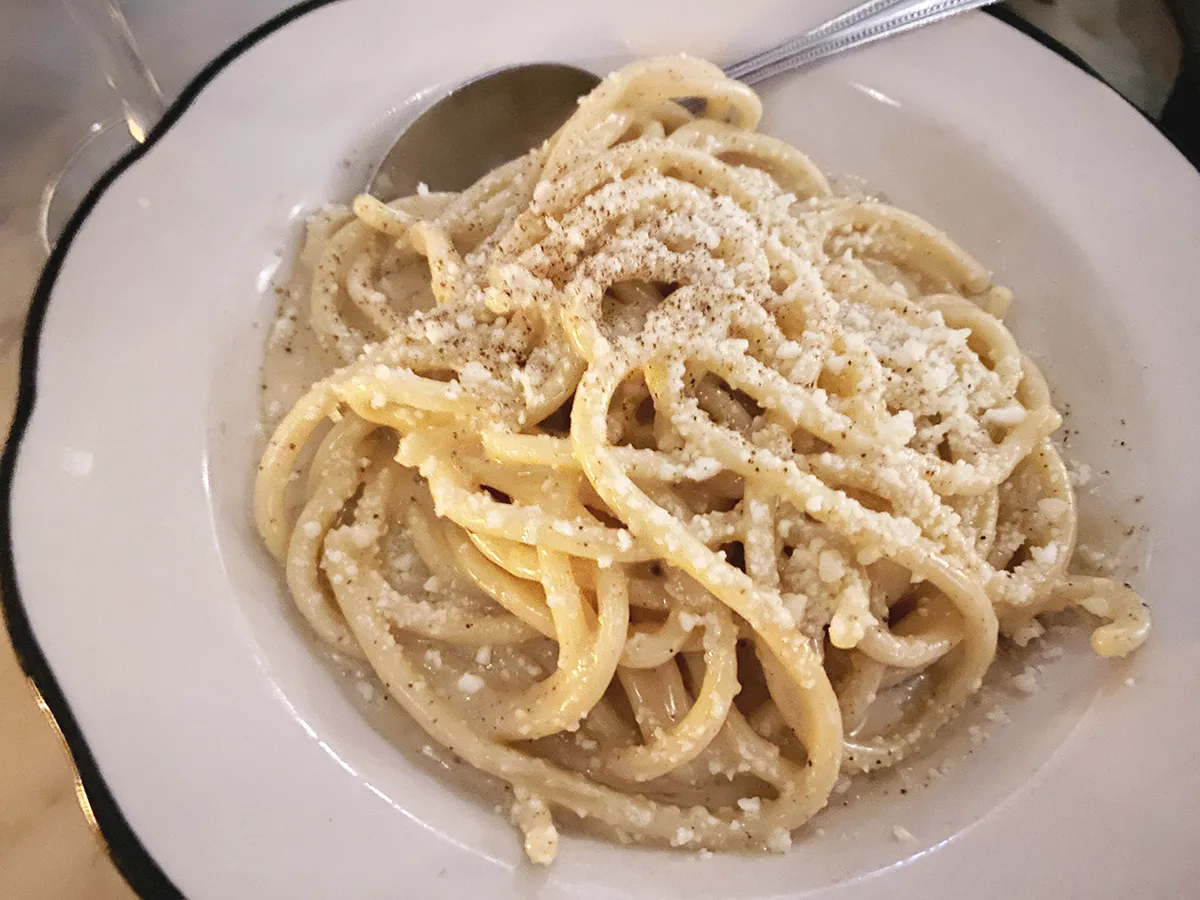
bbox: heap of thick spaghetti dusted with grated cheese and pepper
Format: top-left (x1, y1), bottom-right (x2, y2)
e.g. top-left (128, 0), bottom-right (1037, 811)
top-left (256, 58), bottom-right (1150, 863)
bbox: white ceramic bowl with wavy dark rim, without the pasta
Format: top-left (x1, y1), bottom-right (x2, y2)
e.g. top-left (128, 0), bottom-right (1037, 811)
top-left (0, 0), bottom-right (1200, 900)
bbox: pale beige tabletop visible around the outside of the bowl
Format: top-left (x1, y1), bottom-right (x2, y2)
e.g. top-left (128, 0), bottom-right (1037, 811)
top-left (0, 0), bottom-right (1180, 900)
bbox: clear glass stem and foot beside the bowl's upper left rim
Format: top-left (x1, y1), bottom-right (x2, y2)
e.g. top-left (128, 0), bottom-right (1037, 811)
top-left (38, 0), bottom-right (166, 251)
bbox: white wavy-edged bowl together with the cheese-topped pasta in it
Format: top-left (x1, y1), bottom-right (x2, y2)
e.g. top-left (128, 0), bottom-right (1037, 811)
top-left (2, 0), bottom-right (1200, 900)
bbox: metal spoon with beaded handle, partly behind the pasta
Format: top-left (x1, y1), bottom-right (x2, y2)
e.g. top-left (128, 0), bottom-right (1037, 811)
top-left (367, 0), bottom-right (995, 200)
